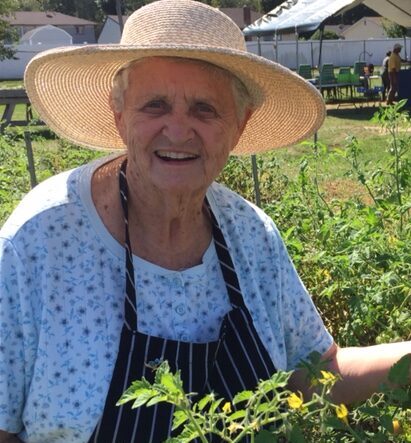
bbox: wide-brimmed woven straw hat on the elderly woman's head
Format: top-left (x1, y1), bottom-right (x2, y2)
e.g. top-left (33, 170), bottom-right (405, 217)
top-left (25, 0), bottom-right (325, 154)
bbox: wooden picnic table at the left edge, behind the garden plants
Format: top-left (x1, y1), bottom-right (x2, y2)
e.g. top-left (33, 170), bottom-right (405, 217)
top-left (0, 88), bottom-right (38, 134)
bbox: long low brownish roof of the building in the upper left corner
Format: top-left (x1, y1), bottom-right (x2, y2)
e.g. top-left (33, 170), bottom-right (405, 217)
top-left (3, 11), bottom-right (96, 26)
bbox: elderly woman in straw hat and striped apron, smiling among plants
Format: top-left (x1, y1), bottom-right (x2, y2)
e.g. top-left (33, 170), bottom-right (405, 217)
top-left (0, 0), bottom-right (410, 443)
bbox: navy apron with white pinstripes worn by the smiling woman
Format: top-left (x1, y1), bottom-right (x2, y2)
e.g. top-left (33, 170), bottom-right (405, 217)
top-left (89, 161), bottom-right (276, 443)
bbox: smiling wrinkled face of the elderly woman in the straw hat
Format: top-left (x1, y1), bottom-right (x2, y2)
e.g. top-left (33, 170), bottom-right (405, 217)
top-left (113, 57), bottom-right (250, 198)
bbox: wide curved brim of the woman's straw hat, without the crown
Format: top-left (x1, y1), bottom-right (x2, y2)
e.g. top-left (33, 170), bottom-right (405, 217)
top-left (25, 45), bottom-right (325, 155)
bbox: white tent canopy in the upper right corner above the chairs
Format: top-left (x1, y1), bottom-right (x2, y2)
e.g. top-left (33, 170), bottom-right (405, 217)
top-left (243, 0), bottom-right (411, 36)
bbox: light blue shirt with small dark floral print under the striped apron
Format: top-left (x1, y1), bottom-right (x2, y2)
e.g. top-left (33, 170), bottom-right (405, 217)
top-left (0, 156), bottom-right (332, 443)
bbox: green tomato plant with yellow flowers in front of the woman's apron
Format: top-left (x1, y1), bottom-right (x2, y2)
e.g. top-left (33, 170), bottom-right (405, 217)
top-left (118, 355), bottom-right (411, 443)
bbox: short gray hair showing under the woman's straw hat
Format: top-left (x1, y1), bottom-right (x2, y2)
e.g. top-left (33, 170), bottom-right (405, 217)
top-left (111, 57), bottom-right (254, 121)
